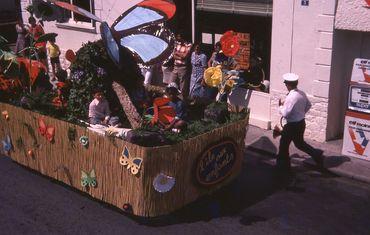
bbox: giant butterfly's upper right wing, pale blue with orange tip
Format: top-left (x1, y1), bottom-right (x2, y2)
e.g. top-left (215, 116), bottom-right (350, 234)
top-left (112, 0), bottom-right (176, 32)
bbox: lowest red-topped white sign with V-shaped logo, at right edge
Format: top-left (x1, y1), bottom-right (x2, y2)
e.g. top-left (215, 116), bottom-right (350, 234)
top-left (342, 111), bottom-right (370, 161)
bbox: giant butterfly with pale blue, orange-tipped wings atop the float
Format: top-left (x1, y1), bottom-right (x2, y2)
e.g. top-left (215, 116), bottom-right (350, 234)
top-left (48, 0), bottom-right (176, 67)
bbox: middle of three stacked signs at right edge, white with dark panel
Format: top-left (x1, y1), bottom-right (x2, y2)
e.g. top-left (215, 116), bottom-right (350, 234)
top-left (348, 85), bottom-right (370, 114)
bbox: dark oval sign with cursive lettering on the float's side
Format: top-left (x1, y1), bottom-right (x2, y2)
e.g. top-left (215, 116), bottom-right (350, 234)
top-left (196, 140), bottom-right (238, 186)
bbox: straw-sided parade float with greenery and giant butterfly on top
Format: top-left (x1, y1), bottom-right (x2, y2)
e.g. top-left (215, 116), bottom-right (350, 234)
top-left (0, 0), bottom-right (249, 217)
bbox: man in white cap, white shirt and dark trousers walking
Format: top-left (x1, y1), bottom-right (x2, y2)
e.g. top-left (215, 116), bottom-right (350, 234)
top-left (277, 73), bottom-right (323, 172)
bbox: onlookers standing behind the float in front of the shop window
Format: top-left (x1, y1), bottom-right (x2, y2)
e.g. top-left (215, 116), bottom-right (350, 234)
top-left (142, 34), bottom-right (269, 99)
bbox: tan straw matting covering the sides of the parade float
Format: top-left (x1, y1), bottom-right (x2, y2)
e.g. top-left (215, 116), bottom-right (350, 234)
top-left (0, 103), bottom-right (248, 217)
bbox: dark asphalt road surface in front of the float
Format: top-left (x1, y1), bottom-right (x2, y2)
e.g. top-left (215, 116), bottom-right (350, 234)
top-left (0, 151), bottom-right (370, 234)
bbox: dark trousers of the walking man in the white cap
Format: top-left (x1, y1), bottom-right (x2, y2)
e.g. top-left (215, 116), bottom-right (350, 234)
top-left (277, 119), bottom-right (320, 170)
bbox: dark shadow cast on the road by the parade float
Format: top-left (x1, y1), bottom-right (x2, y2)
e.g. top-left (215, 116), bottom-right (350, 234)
top-left (131, 151), bottom-right (305, 227)
